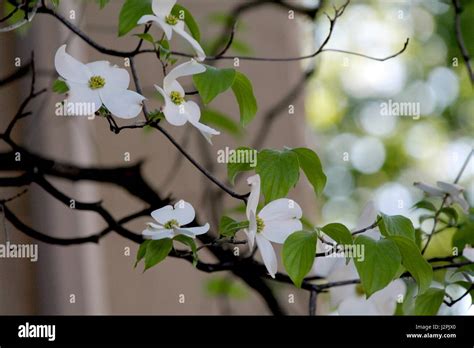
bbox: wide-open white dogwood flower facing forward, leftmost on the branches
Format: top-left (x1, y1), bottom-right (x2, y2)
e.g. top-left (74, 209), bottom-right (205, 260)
top-left (54, 45), bottom-right (145, 119)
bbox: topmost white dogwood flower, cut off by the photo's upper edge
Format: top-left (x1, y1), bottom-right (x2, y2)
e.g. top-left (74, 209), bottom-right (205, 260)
top-left (137, 0), bottom-right (206, 61)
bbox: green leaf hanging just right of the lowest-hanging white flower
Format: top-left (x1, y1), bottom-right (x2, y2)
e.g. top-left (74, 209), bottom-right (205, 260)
top-left (282, 231), bottom-right (318, 287)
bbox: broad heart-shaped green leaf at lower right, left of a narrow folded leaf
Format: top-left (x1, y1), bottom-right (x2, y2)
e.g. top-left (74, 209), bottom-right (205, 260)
top-left (353, 236), bottom-right (401, 298)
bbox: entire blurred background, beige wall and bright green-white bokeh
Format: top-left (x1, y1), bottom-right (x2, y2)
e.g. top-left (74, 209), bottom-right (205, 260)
top-left (0, 0), bottom-right (474, 314)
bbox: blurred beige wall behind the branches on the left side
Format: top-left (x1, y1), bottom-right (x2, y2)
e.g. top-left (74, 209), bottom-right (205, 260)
top-left (0, 0), bottom-right (313, 314)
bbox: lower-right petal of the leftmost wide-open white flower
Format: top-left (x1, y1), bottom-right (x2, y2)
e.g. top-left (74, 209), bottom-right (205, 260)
top-left (100, 87), bottom-right (145, 119)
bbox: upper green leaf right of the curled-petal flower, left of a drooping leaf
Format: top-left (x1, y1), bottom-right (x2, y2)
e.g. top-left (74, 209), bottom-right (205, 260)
top-left (193, 65), bottom-right (236, 104)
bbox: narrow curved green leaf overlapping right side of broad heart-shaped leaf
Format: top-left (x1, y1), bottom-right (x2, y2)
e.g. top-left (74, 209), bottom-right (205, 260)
top-left (388, 236), bottom-right (433, 294)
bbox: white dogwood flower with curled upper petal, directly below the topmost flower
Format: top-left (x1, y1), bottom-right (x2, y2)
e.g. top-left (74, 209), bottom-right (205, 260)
top-left (155, 59), bottom-right (220, 144)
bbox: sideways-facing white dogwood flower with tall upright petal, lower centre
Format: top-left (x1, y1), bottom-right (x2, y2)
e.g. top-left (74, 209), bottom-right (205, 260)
top-left (245, 174), bottom-right (303, 278)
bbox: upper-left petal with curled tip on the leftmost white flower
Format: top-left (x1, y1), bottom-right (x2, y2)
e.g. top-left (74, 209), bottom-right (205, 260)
top-left (54, 45), bottom-right (92, 84)
